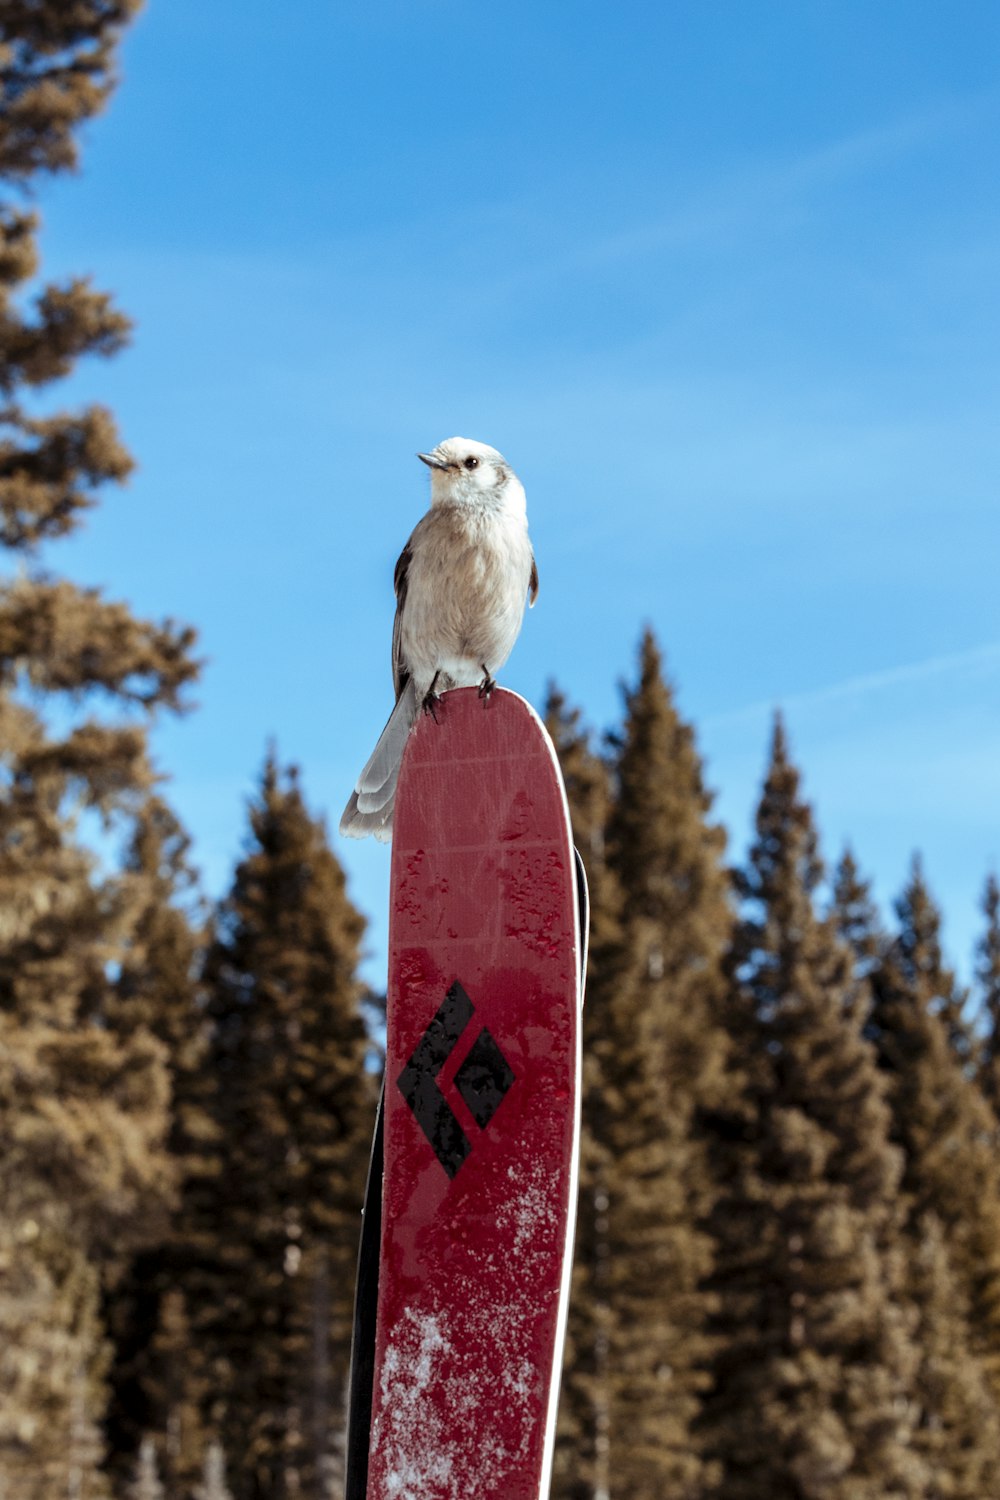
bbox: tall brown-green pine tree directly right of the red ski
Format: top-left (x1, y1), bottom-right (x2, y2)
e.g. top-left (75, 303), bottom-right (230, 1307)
top-left (550, 633), bottom-right (729, 1500)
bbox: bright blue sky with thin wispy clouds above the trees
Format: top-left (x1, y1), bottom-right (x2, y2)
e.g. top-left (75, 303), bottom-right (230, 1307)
top-left (29, 0), bottom-right (1000, 983)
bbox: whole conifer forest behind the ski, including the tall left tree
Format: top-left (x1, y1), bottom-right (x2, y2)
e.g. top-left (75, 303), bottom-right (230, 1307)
top-left (0, 0), bottom-right (1000, 1500)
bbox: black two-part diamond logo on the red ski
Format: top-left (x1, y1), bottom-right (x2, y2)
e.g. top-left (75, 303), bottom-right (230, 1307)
top-left (397, 980), bottom-right (514, 1178)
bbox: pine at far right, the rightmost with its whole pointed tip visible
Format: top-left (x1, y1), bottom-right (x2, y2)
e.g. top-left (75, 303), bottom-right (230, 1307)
top-left (867, 861), bottom-right (1000, 1410)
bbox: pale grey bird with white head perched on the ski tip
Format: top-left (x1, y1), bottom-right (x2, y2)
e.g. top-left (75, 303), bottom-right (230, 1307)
top-left (340, 438), bottom-right (538, 843)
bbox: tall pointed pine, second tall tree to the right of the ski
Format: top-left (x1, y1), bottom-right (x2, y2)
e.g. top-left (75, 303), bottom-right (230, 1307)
top-left (705, 722), bottom-right (925, 1500)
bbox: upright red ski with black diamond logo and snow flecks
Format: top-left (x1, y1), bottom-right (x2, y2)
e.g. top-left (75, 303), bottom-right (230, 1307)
top-left (348, 689), bottom-right (583, 1500)
